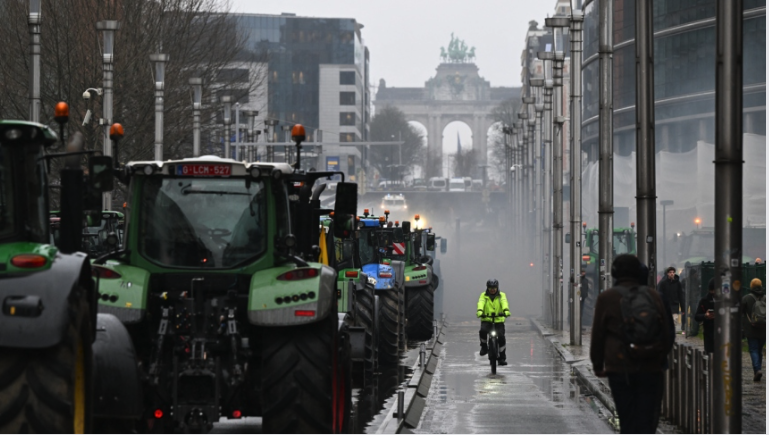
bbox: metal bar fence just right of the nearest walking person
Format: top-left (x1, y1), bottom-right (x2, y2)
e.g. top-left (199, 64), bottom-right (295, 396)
top-left (662, 343), bottom-right (713, 433)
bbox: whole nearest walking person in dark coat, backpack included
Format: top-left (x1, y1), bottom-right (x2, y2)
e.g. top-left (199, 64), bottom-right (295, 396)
top-left (590, 254), bottom-right (672, 433)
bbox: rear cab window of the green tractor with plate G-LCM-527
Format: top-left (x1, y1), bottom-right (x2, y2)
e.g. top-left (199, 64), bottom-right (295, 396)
top-left (139, 177), bottom-right (267, 269)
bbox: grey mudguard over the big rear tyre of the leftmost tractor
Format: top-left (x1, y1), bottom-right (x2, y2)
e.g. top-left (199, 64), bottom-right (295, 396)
top-left (0, 252), bottom-right (95, 349)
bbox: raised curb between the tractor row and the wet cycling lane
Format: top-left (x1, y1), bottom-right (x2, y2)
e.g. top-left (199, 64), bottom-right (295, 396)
top-left (376, 321), bottom-right (446, 434)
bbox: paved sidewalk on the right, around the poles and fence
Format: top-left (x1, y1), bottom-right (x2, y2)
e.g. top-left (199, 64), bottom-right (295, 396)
top-left (532, 320), bottom-right (766, 434)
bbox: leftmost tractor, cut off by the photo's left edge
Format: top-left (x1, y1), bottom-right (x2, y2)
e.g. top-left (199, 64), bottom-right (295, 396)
top-left (0, 118), bottom-right (141, 433)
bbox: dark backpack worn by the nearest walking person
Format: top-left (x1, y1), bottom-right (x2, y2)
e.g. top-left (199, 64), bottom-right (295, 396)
top-left (617, 286), bottom-right (665, 360)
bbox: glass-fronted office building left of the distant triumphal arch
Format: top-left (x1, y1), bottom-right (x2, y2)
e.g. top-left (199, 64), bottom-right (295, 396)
top-left (232, 14), bottom-right (368, 140)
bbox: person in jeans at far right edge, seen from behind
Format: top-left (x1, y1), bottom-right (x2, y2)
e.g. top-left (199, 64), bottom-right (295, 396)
top-left (740, 278), bottom-right (766, 382)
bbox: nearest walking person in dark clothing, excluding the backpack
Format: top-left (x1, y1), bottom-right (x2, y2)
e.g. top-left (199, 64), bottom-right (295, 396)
top-left (590, 254), bottom-right (671, 433)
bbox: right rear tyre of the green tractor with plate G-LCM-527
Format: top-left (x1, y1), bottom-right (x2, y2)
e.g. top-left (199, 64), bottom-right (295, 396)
top-left (261, 313), bottom-right (352, 433)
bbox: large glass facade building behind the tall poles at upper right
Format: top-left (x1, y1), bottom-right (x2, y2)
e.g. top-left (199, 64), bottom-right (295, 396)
top-left (582, 0), bottom-right (766, 161)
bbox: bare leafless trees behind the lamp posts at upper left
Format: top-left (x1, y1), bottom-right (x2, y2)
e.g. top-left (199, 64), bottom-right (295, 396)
top-left (0, 0), bottom-right (266, 162)
